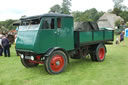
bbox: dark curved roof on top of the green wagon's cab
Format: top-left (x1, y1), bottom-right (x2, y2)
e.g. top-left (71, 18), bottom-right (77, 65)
top-left (20, 13), bottom-right (73, 20)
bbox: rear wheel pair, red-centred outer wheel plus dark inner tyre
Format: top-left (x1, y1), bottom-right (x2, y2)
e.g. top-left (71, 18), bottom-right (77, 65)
top-left (90, 44), bottom-right (106, 62)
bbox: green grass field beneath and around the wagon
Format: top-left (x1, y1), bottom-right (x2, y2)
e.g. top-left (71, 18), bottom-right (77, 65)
top-left (0, 36), bottom-right (128, 85)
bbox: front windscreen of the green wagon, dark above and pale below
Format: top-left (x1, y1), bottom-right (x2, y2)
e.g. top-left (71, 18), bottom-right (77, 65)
top-left (19, 19), bottom-right (40, 31)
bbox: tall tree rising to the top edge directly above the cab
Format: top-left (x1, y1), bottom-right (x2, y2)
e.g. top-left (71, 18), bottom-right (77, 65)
top-left (62, 0), bottom-right (71, 14)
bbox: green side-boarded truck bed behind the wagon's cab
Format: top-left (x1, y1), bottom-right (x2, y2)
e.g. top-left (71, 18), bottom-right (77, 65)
top-left (74, 30), bottom-right (114, 47)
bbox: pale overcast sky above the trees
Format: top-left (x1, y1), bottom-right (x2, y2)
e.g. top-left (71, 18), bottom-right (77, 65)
top-left (0, 0), bottom-right (128, 21)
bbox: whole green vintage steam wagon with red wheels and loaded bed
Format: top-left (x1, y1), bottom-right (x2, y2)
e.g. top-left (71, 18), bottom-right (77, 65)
top-left (16, 13), bottom-right (114, 74)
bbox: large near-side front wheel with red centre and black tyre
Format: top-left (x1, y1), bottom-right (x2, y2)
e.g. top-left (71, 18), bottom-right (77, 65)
top-left (44, 50), bottom-right (68, 74)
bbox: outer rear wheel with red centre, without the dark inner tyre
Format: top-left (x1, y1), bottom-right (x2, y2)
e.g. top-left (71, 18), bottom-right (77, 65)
top-left (95, 44), bottom-right (106, 62)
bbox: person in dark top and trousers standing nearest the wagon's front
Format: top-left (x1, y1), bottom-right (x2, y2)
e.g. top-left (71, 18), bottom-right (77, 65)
top-left (1, 37), bottom-right (10, 57)
